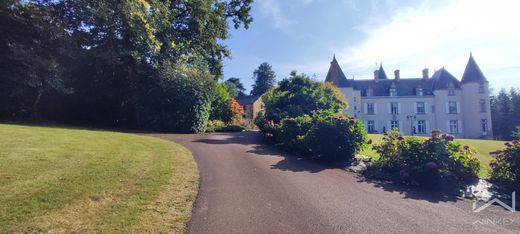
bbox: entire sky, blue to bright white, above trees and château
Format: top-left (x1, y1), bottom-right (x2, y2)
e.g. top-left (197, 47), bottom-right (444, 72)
top-left (224, 0), bottom-right (520, 94)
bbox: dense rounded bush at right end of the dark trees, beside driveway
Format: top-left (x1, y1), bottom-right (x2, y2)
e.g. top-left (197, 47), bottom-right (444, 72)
top-left (140, 65), bottom-right (215, 133)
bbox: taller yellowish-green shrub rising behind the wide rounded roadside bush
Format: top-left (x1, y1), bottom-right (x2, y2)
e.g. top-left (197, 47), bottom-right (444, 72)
top-left (262, 71), bottom-right (348, 123)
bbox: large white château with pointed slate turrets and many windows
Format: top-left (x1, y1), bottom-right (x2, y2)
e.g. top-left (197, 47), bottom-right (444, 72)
top-left (325, 55), bottom-right (493, 139)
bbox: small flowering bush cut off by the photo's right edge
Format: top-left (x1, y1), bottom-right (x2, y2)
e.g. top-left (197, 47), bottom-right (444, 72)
top-left (490, 140), bottom-right (520, 189)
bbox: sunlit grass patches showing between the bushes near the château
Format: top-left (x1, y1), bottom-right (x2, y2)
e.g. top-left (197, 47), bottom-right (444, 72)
top-left (360, 134), bottom-right (505, 178)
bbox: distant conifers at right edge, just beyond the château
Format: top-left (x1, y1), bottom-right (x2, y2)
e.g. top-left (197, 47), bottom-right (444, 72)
top-left (491, 88), bottom-right (520, 140)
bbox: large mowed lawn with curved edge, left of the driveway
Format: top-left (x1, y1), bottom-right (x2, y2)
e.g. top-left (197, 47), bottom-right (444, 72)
top-left (0, 124), bottom-right (198, 233)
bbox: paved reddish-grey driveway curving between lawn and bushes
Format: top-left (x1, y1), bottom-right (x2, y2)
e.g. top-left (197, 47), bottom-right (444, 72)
top-left (155, 132), bottom-right (520, 233)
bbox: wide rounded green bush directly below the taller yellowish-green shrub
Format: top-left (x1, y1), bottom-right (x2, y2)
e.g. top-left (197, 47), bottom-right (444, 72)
top-left (257, 113), bottom-right (367, 162)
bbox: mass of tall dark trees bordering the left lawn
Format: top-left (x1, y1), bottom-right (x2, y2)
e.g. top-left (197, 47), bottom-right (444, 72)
top-left (0, 0), bottom-right (252, 132)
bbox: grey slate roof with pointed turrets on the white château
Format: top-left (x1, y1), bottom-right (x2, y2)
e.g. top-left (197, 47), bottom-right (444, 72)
top-left (325, 57), bottom-right (470, 96)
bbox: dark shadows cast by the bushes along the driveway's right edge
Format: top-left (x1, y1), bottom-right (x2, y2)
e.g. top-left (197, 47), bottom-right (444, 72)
top-left (193, 132), bottom-right (460, 203)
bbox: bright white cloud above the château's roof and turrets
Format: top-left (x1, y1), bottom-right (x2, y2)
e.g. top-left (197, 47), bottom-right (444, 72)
top-left (334, 0), bottom-right (520, 90)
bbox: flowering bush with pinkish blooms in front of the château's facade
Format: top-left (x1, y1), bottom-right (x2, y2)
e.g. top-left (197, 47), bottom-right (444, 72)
top-left (373, 130), bottom-right (480, 184)
